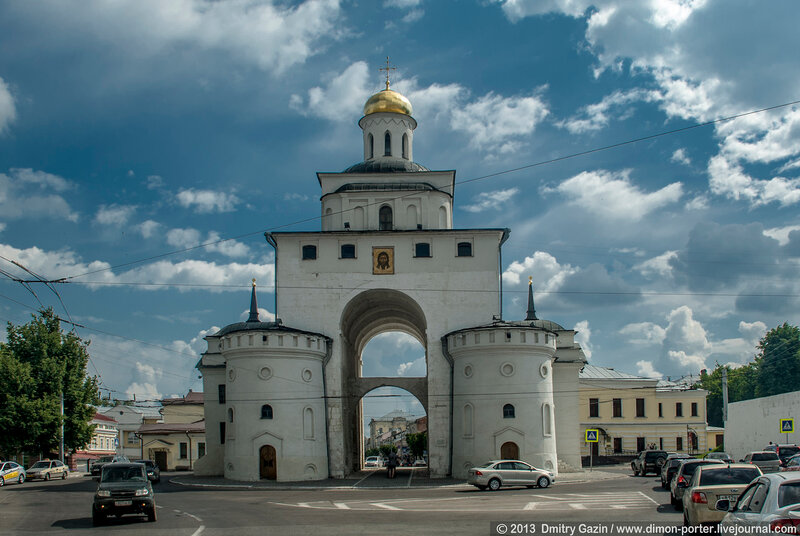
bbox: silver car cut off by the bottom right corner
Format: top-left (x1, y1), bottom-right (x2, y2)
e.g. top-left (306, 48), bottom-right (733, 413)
top-left (715, 473), bottom-right (800, 533)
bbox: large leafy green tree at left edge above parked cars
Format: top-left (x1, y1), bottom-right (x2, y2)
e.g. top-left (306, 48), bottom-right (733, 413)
top-left (0, 309), bottom-right (100, 456)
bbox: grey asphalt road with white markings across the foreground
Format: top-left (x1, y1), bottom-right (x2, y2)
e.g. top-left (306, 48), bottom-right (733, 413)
top-left (0, 470), bottom-right (682, 536)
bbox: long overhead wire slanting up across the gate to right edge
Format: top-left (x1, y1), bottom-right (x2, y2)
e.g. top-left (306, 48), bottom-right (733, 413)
top-left (52, 100), bottom-right (800, 282)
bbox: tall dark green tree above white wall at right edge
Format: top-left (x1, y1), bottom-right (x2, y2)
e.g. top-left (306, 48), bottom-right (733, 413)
top-left (755, 322), bottom-right (800, 396)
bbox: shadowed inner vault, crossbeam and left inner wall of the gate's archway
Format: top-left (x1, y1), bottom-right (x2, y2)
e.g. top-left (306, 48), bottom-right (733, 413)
top-left (340, 289), bottom-right (430, 472)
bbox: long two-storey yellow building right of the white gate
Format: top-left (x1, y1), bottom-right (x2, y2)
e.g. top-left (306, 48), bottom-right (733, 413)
top-left (579, 364), bottom-right (716, 456)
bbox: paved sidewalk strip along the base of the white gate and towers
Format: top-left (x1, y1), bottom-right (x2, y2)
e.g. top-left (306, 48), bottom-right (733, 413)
top-left (169, 467), bottom-right (628, 490)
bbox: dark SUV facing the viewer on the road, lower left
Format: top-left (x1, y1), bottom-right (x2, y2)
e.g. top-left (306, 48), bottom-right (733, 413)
top-left (92, 463), bottom-right (156, 526)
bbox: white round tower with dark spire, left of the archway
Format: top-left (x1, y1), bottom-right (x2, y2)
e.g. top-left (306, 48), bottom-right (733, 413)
top-left (195, 279), bottom-right (331, 481)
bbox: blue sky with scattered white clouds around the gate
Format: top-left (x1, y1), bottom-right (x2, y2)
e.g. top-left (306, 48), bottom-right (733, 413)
top-left (0, 0), bottom-right (800, 422)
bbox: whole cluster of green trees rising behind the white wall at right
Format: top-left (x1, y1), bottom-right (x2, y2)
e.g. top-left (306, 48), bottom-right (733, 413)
top-left (697, 323), bottom-right (800, 426)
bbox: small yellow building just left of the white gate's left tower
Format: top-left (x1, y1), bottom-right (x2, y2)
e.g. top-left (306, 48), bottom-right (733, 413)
top-left (139, 391), bottom-right (206, 471)
